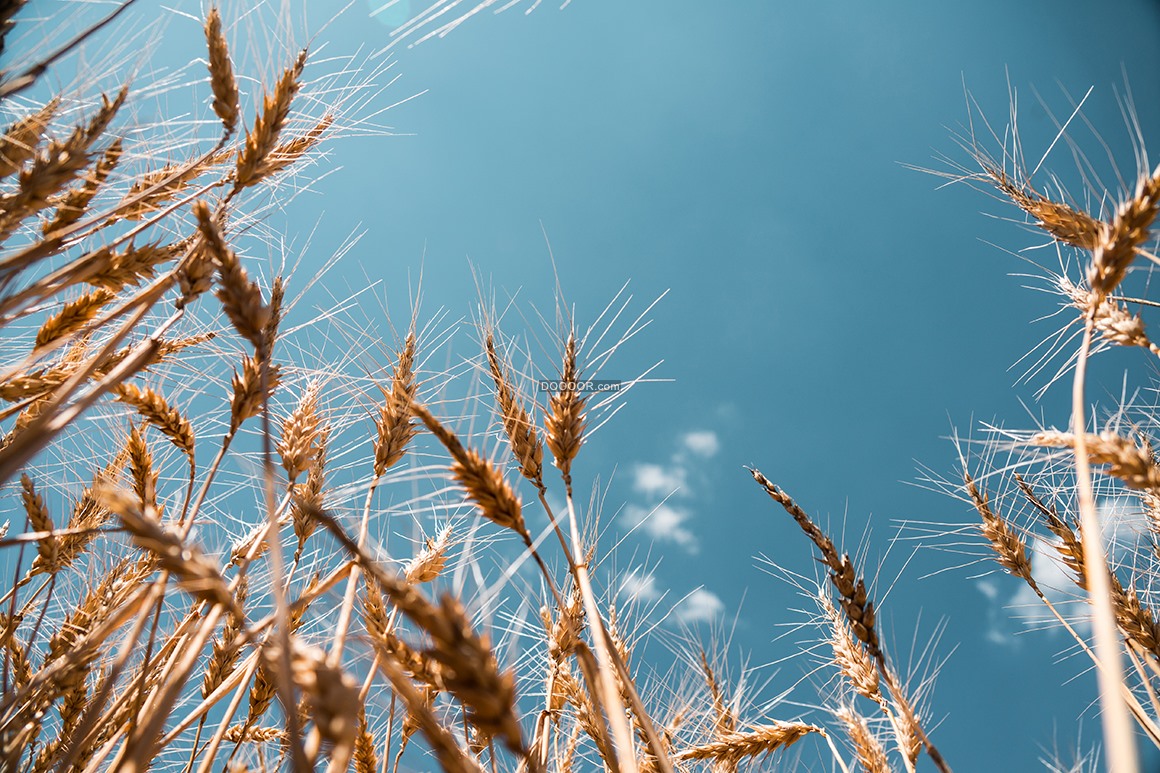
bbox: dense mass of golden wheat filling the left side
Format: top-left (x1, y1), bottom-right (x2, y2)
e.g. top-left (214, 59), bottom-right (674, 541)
top-left (0, 3), bottom-right (844, 773)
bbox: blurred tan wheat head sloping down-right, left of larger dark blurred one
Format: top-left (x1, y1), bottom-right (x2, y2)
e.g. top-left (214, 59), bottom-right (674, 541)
top-left (97, 486), bottom-right (242, 617)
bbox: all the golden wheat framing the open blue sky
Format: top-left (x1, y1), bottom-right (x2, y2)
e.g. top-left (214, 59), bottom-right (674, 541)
top-left (0, 2), bottom-right (1160, 773)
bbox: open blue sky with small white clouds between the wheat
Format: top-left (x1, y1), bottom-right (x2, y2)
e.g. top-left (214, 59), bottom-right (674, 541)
top-left (9, 0), bottom-right (1160, 771)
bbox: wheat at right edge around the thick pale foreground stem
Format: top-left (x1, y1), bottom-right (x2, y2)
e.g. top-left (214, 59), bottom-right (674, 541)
top-left (900, 93), bottom-right (1160, 771)
